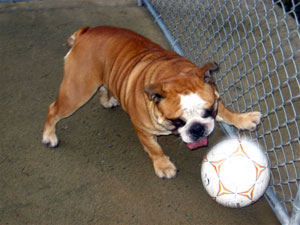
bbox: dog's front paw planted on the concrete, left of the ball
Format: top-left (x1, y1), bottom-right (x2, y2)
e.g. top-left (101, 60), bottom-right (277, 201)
top-left (153, 156), bottom-right (177, 178)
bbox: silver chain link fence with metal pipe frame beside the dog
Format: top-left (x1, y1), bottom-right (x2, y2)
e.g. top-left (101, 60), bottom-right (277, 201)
top-left (138, 0), bottom-right (300, 224)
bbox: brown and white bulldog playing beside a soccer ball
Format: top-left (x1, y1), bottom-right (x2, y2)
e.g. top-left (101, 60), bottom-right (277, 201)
top-left (43, 26), bottom-right (261, 178)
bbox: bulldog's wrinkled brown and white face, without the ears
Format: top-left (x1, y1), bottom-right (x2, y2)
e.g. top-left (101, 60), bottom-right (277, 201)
top-left (146, 74), bottom-right (219, 149)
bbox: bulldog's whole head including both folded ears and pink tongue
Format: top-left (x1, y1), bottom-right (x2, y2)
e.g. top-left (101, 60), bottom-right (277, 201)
top-left (145, 63), bottom-right (219, 149)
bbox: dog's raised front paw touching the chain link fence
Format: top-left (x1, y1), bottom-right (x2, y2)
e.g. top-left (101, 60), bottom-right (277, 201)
top-left (237, 112), bottom-right (262, 131)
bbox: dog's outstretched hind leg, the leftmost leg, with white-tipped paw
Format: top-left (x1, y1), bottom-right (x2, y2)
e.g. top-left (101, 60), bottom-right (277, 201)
top-left (42, 64), bottom-right (101, 147)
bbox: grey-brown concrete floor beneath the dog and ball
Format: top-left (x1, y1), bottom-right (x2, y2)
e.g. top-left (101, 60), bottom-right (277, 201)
top-left (0, 0), bottom-right (278, 225)
